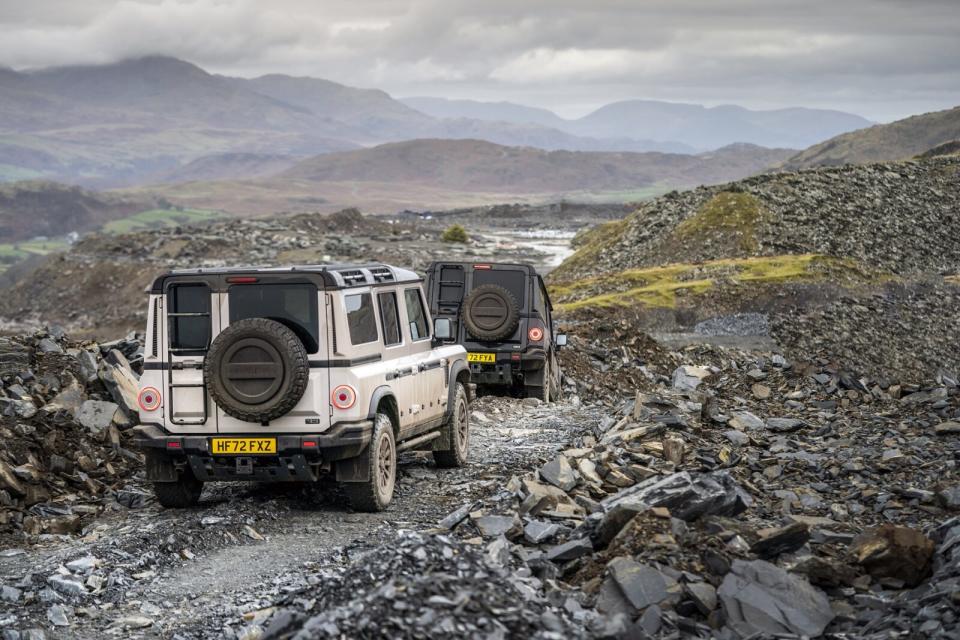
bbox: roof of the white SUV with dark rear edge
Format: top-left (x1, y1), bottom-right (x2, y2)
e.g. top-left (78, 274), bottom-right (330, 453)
top-left (150, 263), bottom-right (421, 293)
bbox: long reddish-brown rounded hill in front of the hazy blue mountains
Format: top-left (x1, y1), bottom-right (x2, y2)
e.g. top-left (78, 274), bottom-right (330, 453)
top-left (129, 139), bottom-right (794, 215)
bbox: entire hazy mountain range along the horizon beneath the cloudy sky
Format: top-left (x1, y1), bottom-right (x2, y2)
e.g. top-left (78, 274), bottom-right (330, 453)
top-left (0, 56), bottom-right (869, 187)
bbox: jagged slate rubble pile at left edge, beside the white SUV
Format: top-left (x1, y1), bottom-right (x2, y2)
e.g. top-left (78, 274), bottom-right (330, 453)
top-left (0, 329), bottom-right (143, 540)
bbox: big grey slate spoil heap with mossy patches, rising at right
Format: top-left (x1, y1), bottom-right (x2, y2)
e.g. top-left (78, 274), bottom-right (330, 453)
top-left (558, 156), bottom-right (960, 280)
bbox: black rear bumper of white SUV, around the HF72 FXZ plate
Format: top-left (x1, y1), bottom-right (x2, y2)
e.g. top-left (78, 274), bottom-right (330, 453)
top-left (133, 420), bottom-right (373, 482)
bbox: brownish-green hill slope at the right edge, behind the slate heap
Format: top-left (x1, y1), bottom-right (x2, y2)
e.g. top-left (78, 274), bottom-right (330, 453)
top-left (784, 107), bottom-right (960, 169)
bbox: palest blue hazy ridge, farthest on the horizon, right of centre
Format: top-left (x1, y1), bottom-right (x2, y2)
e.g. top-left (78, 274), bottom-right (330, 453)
top-left (403, 97), bottom-right (871, 153)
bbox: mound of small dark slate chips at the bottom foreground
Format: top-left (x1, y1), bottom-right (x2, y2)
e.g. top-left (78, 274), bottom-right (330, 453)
top-left (239, 531), bottom-right (604, 640)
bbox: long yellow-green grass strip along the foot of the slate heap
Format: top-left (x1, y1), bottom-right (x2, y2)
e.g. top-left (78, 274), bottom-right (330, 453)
top-left (548, 253), bottom-right (891, 311)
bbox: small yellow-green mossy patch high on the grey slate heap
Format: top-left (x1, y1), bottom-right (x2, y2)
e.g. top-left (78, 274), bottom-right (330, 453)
top-left (673, 191), bottom-right (770, 254)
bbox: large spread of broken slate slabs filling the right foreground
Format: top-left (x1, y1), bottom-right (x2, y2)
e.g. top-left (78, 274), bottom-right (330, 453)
top-left (441, 338), bottom-right (960, 638)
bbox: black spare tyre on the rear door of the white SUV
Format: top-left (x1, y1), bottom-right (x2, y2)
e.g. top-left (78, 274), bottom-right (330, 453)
top-left (203, 318), bottom-right (310, 423)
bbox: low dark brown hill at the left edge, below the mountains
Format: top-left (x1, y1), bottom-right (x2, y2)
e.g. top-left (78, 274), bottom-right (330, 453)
top-left (0, 181), bottom-right (155, 242)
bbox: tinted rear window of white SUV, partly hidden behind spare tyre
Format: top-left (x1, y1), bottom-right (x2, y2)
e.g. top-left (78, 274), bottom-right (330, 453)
top-left (229, 283), bottom-right (320, 353)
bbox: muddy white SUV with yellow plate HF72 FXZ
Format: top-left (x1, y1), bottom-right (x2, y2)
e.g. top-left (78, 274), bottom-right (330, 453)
top-left (130, 264), bottom-right (472, 511)
